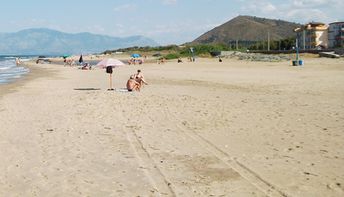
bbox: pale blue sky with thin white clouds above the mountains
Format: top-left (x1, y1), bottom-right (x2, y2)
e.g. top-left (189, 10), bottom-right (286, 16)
top-left (0, 0), bottom-right (344, 45)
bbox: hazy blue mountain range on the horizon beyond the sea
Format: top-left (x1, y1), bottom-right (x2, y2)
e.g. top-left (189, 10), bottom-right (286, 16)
top-left (0, 28), bottom-right (158, 55)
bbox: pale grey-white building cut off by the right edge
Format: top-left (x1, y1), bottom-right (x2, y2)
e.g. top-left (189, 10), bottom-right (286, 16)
top-left (328, 22), bottom-right (344, 48)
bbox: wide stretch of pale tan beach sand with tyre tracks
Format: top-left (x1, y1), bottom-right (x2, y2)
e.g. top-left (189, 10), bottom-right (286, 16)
top-left (0, 58), bottom-right (344, 197)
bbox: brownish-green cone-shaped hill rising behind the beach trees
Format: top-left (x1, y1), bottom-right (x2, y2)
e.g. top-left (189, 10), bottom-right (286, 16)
top-left (192, 16), bottom-right (301, 44)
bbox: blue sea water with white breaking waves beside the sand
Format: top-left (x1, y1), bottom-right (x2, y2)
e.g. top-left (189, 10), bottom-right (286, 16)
top-left (0, 55), bottom-right (30, 84)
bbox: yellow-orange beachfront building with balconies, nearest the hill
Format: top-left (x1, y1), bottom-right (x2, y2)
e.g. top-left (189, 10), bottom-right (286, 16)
top-left (294, 22), bottom-right (328, 50)
